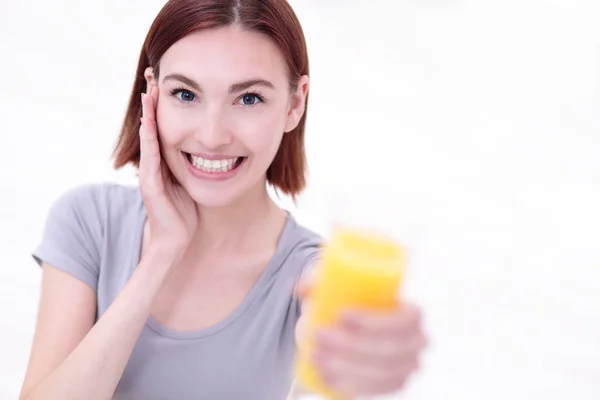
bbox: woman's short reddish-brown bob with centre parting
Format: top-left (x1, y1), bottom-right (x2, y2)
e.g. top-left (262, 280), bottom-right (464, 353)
top-left (113, 0), bottom-right (309, 198)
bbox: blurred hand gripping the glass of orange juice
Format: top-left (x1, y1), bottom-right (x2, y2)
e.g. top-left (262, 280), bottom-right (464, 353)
top-left (314, 304), bottom-right (427, 397)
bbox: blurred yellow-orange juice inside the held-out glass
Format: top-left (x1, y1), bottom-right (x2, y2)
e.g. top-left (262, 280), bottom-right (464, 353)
top-left (296, 229), bottom-right (405, 399)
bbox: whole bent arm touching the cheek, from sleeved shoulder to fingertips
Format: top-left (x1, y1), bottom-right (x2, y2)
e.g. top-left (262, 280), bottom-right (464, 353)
top-left (20, 86), bottom-right (198, 400)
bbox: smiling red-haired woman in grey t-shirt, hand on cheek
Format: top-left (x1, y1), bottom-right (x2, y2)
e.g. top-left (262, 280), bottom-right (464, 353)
top-left (21, 0), bottom-right (424, 400)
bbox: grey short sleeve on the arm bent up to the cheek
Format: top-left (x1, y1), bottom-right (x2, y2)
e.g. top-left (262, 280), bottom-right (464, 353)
top-left (32, 185), bottom-right (103, 291)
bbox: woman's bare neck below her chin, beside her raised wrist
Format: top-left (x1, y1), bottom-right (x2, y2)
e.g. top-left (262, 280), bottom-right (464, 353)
top-left (194, 184), bottom-right (285, 251)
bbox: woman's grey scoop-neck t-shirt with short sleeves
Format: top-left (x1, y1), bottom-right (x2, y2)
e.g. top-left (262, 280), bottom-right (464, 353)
top-left (33, 184), bottom-right (321, 400)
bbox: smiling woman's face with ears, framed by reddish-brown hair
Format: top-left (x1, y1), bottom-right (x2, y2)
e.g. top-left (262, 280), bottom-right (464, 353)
top-left (146, 26), bottom-right (308, 207)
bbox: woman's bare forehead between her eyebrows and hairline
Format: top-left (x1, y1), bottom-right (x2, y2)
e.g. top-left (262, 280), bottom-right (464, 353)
top-left (160, 26), bottom-right (287, 86)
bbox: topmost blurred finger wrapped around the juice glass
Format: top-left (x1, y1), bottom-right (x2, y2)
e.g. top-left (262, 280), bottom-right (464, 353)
top-left (340, 303), bottom-right (421, 336)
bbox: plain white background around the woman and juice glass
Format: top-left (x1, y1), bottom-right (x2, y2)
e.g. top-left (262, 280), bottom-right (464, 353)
top-left (0, 0), bottom-right (600, 400)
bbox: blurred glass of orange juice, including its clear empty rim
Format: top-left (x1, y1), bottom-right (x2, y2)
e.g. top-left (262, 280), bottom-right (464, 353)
top-left (292, 192), bottom-right (408, 400)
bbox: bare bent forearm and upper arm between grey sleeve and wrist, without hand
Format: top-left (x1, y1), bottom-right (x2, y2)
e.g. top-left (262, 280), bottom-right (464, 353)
top-left (20, 251), bottom-right (171, 400)
